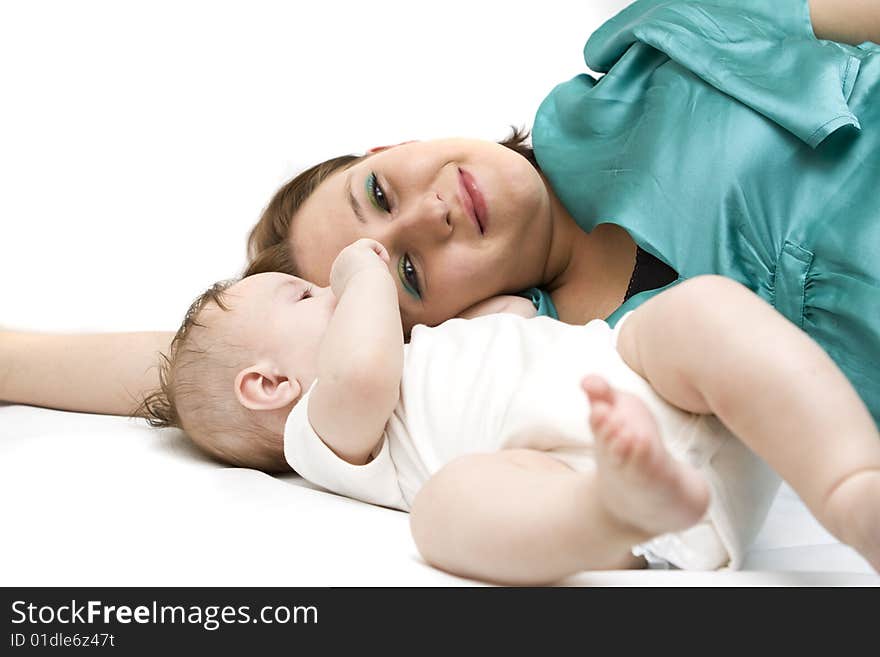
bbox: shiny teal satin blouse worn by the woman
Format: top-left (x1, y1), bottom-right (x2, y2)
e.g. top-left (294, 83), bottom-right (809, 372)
top-left (532, 0), bottom-right (880, 424)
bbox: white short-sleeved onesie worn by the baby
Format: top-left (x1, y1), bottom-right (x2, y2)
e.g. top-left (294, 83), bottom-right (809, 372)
top-left (284, 314), bottom-right (779, 570)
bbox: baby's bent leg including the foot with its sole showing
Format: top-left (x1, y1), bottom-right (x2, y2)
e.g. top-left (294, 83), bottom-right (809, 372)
top-left (410, 383), bottom-right (709, 584)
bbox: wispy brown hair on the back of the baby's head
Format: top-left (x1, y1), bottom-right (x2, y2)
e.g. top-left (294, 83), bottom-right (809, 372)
top-left (132, 279), bottom-right (290, 472)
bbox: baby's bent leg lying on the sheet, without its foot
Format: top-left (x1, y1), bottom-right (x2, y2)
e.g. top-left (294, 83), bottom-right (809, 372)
top-left (410, 449), bottom-right (651, 585)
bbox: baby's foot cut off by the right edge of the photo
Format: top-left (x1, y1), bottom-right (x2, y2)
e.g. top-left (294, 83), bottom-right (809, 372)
top-left (828, 470), bottom-right (880, 573)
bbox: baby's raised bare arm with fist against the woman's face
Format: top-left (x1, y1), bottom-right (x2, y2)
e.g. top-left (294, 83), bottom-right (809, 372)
top-left (308, 239), bottom-right (403, 465)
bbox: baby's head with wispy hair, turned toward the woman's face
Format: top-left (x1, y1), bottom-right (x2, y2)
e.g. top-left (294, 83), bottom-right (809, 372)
top-left (136, 272), bottom-right (336, 472)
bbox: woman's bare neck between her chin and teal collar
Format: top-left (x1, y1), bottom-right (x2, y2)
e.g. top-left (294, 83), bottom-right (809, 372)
top-left (543, 184), bottom-right (636, 324)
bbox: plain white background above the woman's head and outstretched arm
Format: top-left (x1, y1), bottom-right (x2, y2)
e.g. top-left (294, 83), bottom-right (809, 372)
top-left (0, 0), bottom-right (627, 331)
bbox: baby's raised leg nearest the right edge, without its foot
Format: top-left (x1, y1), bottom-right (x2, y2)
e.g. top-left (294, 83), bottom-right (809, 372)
top-left (618, 276), bottom-right (880, 568)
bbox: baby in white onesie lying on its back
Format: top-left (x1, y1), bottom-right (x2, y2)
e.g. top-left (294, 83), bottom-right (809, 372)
top-left (143, 240), bottom-right (880, 584)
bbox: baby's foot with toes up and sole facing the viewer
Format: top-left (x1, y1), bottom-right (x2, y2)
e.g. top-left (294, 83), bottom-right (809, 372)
top-left (581, 375), bottom-right (709, 536)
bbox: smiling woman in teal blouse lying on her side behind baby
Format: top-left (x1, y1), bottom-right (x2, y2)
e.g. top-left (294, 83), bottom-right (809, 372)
top-left (0, 0), bottom-right (880, 421)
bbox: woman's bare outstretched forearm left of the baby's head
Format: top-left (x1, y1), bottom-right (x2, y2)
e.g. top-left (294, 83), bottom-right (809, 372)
top-left (0, 332), bottom-right (174, 415)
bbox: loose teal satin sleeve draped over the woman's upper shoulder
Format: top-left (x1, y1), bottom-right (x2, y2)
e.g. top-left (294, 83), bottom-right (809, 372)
top-left (584, 0), bottom-right (862, 148)
